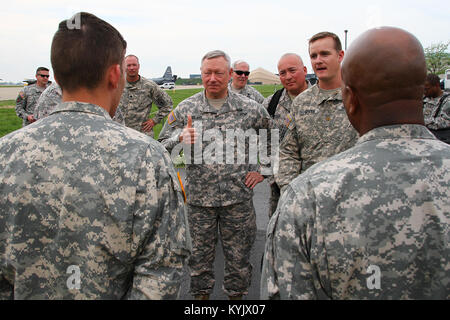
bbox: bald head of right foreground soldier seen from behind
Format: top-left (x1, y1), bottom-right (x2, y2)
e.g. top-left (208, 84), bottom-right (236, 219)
top-left (342, 27), bottom-right (427, 133)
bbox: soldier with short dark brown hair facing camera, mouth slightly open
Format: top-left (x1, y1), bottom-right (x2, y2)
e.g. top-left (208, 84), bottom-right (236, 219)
top-left (275, 32), bottom-right (358, 192)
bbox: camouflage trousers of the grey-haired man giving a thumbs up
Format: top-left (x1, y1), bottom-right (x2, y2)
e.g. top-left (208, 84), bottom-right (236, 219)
top-left (188, 199), bottom-right (256, 296)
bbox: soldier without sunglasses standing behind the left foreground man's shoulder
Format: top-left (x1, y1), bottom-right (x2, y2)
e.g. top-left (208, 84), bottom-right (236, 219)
top-left (114, 55), bottom-right (173, 137)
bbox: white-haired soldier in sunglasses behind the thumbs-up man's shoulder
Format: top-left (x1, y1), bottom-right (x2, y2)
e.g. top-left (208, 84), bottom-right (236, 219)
top-left (228, 60), bottom-right (264, 103)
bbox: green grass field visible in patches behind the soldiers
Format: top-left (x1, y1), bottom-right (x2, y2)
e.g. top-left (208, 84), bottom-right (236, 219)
top-left (0, 85), bottom-right (281, 138)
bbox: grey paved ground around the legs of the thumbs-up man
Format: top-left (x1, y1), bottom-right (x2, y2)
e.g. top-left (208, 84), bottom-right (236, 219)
top-left (180, 170), bottom-right (270, 300)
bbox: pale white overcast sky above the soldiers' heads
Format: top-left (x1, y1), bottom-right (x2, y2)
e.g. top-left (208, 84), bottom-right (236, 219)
top-left (0, 0), bottom-right (450, 81)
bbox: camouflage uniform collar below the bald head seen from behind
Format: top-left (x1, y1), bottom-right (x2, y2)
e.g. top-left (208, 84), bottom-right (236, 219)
top-left (357, 124), bottom-right (435, 144)
